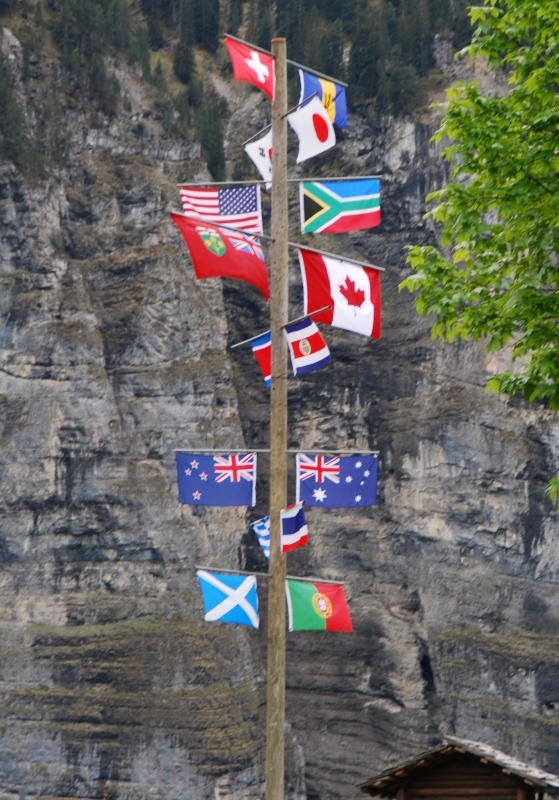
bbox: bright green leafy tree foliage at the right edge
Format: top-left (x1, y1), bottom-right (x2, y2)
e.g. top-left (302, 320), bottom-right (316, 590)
top-left (402, 0), bottom-right (559, 411)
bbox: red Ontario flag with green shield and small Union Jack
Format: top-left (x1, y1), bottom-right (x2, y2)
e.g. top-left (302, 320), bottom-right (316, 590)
top-left (170, 214), bottom-right (270, 302)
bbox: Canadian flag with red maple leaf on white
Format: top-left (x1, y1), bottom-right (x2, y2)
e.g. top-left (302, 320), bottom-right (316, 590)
top-left (299, 248), bottom-right (381, 339)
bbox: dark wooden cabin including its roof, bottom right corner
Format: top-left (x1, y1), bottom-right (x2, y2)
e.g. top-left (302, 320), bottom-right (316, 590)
top-left (359, 737), bottom-right (559, 800)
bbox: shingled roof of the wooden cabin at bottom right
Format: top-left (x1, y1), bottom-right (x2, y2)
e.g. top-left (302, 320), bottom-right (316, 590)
top-left (359, 736), bottom-right (559, 797)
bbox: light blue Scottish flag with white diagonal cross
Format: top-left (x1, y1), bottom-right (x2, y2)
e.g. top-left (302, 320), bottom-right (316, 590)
top-left (196, 569), bottom-right (259, 628)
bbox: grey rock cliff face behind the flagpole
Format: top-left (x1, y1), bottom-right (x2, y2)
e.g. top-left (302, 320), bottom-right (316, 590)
top-left (0, 26), bottom-right (559, 800)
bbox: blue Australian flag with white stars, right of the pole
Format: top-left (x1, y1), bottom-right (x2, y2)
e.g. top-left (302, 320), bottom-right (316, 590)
top-left (297, 453), bottom-right (378, 508)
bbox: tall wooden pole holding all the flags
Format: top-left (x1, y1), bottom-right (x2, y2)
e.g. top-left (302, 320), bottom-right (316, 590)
top-left (266, 39), bottom-right (288, 800)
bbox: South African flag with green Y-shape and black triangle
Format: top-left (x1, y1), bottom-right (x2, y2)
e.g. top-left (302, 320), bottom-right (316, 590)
top-left (299, 178), bottom-right (380, 233)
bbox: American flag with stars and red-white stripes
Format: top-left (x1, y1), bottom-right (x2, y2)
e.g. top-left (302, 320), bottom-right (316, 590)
top-left (180, 184), bottom-right (264, 233)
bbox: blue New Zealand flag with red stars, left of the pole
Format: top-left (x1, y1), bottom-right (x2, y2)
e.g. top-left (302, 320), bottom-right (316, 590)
top-left (177, 453), bottom-right (256, 506)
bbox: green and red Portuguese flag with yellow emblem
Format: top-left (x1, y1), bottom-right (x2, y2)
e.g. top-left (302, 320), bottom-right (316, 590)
top-left (285, 580), bottom-right (353, 631)
